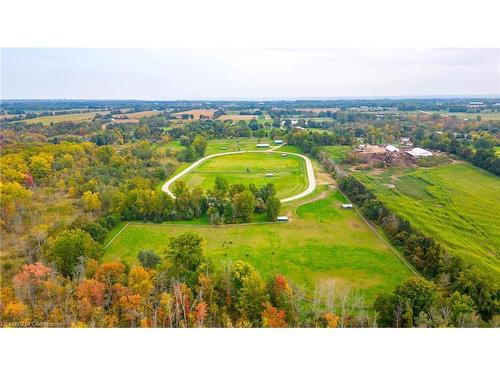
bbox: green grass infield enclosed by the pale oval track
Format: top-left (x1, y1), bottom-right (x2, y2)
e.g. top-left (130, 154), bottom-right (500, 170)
top-left (181, 152), bottom-right (307, 198)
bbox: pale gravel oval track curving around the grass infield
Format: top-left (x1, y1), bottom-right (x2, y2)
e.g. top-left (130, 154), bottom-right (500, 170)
top-left (161, 146), bottom-right (316, 203)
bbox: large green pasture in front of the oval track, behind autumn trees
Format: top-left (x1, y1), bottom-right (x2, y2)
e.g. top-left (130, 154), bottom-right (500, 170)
top-left (104, 190), bottom-right (411, 301)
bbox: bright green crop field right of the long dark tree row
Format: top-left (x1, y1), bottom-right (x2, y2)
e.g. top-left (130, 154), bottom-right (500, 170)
top-left (358, 163), bottom-right (500, 276)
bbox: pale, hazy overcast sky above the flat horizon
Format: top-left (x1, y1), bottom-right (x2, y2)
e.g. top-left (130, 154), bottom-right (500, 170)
top-left (0, 48), bottom-right (500, 100)
